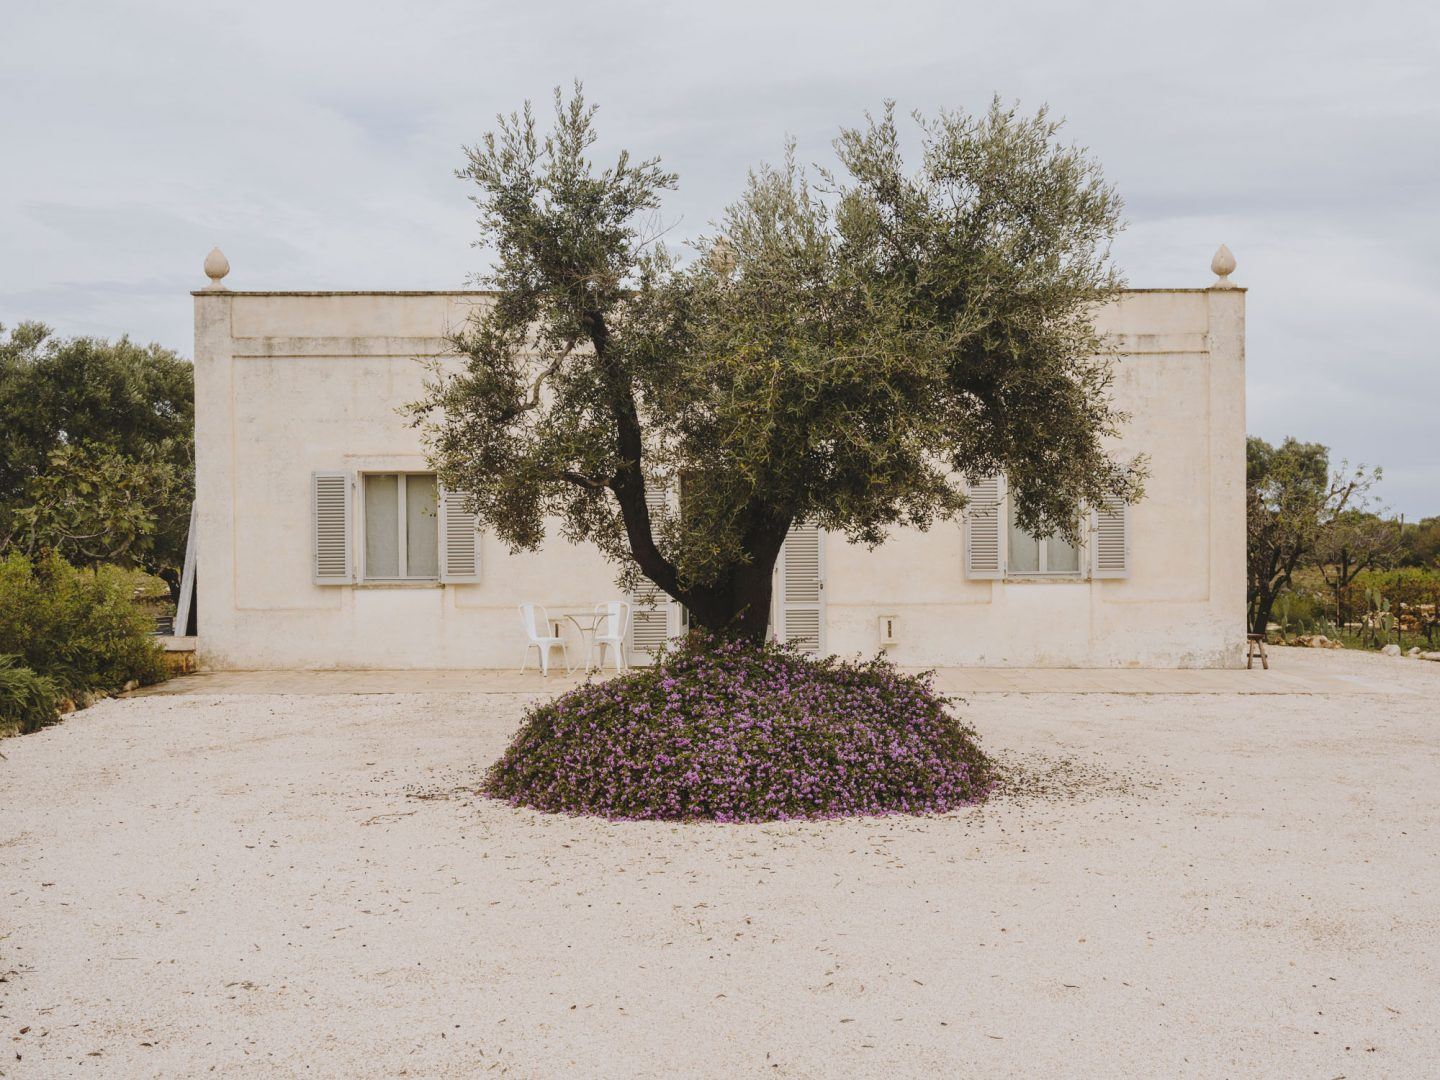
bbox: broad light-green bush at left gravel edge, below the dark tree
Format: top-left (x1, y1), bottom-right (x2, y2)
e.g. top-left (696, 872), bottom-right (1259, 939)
top-left (0, 554), bottom-right (166, 698)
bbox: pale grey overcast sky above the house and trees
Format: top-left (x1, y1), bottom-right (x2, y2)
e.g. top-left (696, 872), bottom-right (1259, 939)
top-left (0, 0), bottom-right (1440, 518)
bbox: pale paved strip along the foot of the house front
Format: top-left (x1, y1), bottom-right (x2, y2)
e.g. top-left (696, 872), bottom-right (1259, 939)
top-left (137, 649), bottom-right (1416, 696)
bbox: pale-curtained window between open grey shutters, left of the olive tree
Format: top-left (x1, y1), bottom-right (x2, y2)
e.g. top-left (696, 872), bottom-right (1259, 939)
top-left (363, 472), bottom-right (441, 582)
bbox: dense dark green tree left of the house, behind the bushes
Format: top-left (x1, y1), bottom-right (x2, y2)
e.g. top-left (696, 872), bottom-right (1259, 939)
top-left (0, 323), bottom-right (194, 590)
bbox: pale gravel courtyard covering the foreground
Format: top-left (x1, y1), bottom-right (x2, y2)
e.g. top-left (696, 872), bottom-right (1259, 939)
top-left (0, 649), bottom-right (1440, 1080)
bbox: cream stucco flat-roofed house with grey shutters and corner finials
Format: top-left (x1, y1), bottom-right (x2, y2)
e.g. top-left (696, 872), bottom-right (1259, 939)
top-left (194, 248), bottom-right (1246, 668)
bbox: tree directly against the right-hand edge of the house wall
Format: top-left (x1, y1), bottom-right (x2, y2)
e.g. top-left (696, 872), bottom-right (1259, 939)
top-left (1246, 436), bottom-right (1381, 634)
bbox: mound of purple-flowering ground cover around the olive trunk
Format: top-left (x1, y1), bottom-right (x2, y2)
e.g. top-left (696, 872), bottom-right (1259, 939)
top-left (482, 634), bottom-right (992, 821)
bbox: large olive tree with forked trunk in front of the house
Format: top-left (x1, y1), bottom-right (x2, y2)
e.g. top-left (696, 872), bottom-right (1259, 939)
top-left (415, 86), bottom-right (1142, 638)
